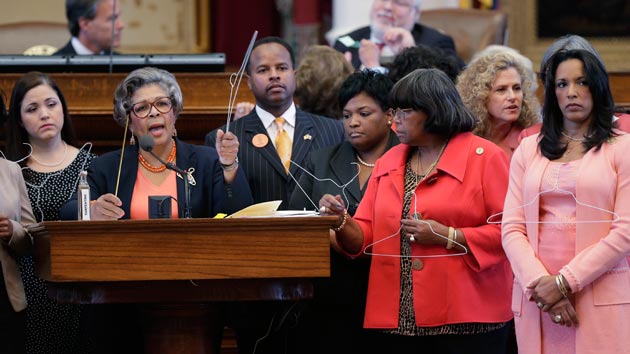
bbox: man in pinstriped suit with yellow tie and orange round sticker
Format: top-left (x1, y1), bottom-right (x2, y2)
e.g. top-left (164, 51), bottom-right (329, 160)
top-left (205, 37), bottom-right (344, 208)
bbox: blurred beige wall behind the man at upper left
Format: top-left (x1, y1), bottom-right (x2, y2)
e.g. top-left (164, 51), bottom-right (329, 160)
top-left (0, 0), bottom-right (210, 53)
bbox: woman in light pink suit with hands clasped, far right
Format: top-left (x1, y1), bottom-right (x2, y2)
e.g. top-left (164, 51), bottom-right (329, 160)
top-left (502, 50), bottom-right (630, 354)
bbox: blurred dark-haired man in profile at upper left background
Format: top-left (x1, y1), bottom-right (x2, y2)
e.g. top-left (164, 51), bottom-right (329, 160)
top-left (54, 0), bottom-right (125, 55)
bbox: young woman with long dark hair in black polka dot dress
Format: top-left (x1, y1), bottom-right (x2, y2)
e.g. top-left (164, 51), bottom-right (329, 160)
top-left (7, 72), bottom-right (95, 354)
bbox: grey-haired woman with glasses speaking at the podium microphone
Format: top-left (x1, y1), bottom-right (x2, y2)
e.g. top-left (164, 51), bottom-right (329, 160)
top-left (64, 67), bottom-right (252, 220)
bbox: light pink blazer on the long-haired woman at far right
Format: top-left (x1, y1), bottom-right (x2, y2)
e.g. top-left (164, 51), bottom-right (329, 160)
top-left (502, 132), bottom-right (630, 354)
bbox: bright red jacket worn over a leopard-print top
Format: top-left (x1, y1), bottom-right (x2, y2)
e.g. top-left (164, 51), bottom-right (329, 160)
top-left (354, 133), bottom-right (512, 328)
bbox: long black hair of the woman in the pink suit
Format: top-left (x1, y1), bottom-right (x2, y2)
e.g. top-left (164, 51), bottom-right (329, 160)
top-left (538, 49), bottom-right (616, 160)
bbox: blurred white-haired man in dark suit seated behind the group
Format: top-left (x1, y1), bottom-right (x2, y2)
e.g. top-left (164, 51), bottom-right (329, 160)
top-left (334, 0), bottom-right (464, 69)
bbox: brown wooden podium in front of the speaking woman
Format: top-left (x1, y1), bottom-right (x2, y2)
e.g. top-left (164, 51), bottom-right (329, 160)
top-left (31, 216), bottom-right (338, 353)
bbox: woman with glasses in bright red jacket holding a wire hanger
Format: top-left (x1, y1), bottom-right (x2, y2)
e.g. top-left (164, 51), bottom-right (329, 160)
top-left (319, 69), bottom-right (512, 353)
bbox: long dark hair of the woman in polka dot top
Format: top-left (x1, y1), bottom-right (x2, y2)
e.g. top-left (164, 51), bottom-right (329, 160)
top-left (7, 71), bottom-right (76, 165)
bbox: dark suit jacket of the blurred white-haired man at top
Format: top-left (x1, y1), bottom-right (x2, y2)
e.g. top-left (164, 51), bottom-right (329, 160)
top-left (334, 23), bottom-right (464, 69)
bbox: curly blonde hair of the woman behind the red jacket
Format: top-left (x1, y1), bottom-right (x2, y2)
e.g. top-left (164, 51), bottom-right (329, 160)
top-left (457, 47), bottom-right (540, 138)
